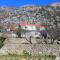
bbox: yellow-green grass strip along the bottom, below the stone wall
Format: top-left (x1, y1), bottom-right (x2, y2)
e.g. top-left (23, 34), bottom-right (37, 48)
top-left (0, 55), bottom-right (55, 60)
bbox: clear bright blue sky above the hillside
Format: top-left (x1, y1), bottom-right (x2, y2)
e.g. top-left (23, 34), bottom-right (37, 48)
top-left (0, 0), bottom-right (60, 7)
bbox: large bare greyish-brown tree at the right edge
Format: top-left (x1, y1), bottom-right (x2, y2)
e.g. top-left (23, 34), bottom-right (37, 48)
top-left (48, 27), bottom-right (60, 43)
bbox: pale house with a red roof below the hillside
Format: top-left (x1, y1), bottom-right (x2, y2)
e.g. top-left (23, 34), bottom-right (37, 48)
top-left (19, 23), bottom-right (45, 37)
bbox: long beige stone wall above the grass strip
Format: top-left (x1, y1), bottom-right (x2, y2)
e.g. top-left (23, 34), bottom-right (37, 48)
top-left (0, 38), bottom-right (60, 56)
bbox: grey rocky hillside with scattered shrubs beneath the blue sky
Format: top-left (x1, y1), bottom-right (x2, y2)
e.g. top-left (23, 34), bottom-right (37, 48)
top-left (0, 3), bottom-right (60, 29)
